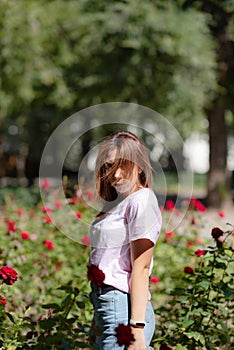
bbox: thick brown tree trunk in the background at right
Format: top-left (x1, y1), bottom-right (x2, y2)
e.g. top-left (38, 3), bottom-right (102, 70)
top-left (207, 100), bottom-right (230, 208)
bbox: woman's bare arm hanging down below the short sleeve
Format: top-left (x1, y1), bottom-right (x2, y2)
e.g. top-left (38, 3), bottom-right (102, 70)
top-left (128, 238), bottom-right (154, 350)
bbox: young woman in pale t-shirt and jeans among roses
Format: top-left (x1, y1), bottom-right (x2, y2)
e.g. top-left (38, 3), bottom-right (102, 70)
top-left (89, 131), bottom-right (161, 350)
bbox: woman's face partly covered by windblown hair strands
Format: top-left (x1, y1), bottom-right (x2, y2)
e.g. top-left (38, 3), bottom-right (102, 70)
top-left (105, 151), bottom-right (140, 195)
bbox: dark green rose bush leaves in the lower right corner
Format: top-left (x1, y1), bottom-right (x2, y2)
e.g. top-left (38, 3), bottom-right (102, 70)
top-left (154, 229), bottom-right (234, 350)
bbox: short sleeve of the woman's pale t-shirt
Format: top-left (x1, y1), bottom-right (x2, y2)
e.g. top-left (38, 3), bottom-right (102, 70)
top-left (126, 189), bottom-right (162, 244)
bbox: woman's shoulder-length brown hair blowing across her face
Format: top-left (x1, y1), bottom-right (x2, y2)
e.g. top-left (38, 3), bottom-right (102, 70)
top-left (95, 131), bottom-right (152, 202)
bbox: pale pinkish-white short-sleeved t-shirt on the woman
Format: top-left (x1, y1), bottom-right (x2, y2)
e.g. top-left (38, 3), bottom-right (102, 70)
top-left (90, 188), bottom-right (162, 293)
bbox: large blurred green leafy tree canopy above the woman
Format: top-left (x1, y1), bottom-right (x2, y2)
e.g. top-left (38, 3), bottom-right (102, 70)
top-left (0, 0), bottom-right (216, 194)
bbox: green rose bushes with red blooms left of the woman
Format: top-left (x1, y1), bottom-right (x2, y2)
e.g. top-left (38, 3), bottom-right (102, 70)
top-left (0, 189), bottom-right (91, 349)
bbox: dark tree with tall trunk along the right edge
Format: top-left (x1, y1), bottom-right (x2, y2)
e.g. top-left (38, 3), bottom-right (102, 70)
top-left (183, 0), bottom-right (234, 207)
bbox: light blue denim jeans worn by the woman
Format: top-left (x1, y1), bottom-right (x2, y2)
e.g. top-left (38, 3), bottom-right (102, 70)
top-left (90, 286), bottom-right (155, 350)
